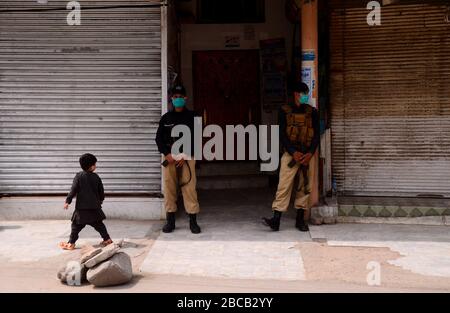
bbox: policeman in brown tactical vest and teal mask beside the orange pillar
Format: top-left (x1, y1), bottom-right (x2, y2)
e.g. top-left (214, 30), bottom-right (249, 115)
top-left (263, 83), bottom-right (320, 231)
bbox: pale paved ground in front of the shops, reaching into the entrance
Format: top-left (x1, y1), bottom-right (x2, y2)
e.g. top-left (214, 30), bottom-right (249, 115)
top-left (0, 190), bottom-right (450, 292)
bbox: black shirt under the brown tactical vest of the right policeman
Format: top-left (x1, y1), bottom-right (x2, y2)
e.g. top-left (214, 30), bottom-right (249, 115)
top-left (278, 104), bottom-right (320, 155)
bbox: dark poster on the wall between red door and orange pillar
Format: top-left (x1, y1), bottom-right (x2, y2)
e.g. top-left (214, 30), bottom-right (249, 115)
top-left (259, 38), bottom-right (288, 112)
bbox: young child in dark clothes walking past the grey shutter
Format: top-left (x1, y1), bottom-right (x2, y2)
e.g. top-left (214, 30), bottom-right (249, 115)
top-left (59, 153), bottom-right (112, 250)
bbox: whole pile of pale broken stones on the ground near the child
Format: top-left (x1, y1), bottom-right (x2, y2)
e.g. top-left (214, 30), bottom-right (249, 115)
top-left (57, 243), bottom-right (133, 287)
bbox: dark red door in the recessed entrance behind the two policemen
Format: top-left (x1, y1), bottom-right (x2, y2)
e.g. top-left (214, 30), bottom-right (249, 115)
top-left (193, 50), bottom-right (261, 159)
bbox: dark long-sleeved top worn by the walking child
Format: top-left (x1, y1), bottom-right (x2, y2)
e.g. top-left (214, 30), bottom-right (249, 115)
top-left (66, 171), bottom-right (105, 210)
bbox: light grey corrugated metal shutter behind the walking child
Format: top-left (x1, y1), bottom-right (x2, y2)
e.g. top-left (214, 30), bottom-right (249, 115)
top-left (0, 0), bottom-right (161, 194)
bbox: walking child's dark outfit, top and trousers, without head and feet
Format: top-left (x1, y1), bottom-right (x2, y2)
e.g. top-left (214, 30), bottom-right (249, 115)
top-left (66, 171), bottom-right (110, 243)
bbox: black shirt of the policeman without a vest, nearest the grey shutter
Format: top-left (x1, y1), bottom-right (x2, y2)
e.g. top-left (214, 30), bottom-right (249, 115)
top-left (155, 108), bottom-right (195, 156)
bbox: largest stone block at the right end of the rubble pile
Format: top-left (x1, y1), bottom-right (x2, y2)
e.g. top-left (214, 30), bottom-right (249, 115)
top-left (87, 252), bottom-right (133, 287)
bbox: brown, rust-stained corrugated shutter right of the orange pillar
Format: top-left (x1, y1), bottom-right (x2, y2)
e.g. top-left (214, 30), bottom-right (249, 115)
top-left (330, 1), bottom-right (450, 197)
